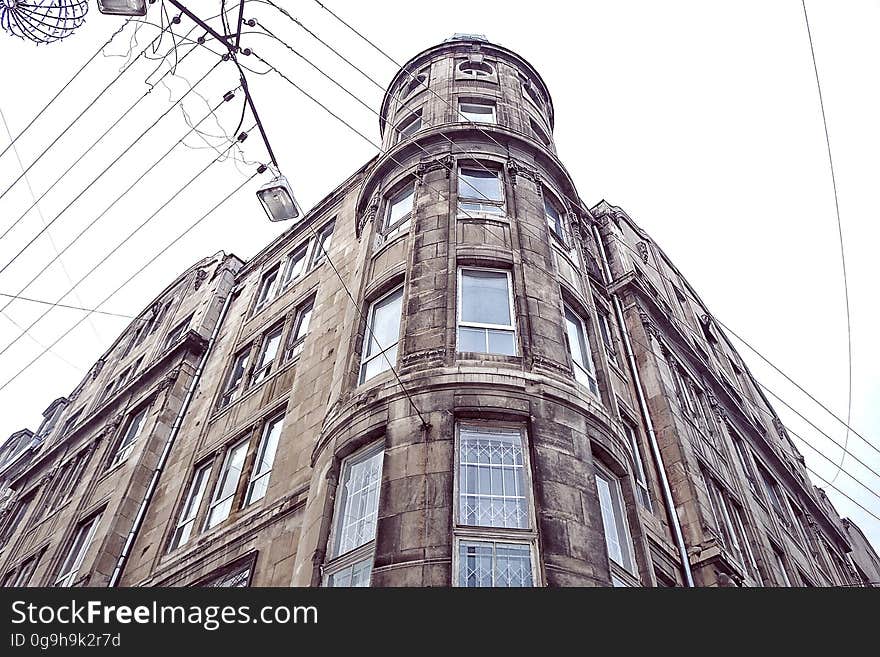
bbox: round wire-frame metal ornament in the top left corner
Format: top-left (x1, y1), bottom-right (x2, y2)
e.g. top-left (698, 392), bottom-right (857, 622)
top-left (0, 0), bottom-right (89, 43)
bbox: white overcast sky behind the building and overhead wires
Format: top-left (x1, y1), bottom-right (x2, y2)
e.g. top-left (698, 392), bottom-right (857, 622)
top-left (0, 0), bottom-right (880, 546)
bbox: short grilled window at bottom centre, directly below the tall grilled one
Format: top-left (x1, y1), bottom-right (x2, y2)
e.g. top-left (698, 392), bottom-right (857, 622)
top-left (458, 541), bottom-right (535, 587)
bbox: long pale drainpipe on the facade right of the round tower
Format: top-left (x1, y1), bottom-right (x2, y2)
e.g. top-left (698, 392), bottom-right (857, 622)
top-left (592, 225), bottom-right (694, 587)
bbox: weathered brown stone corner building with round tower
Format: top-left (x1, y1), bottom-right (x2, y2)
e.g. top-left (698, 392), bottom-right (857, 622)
top-left (0, 35), bottom-right (880, 586)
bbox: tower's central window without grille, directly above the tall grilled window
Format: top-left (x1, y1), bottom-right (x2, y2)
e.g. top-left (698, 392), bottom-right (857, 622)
top-left (458, 269), bottom-right (516, 356)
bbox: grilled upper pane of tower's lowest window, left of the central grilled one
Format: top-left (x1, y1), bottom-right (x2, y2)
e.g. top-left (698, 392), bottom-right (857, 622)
top-left (332, 443), bottom-right (385, 557)
